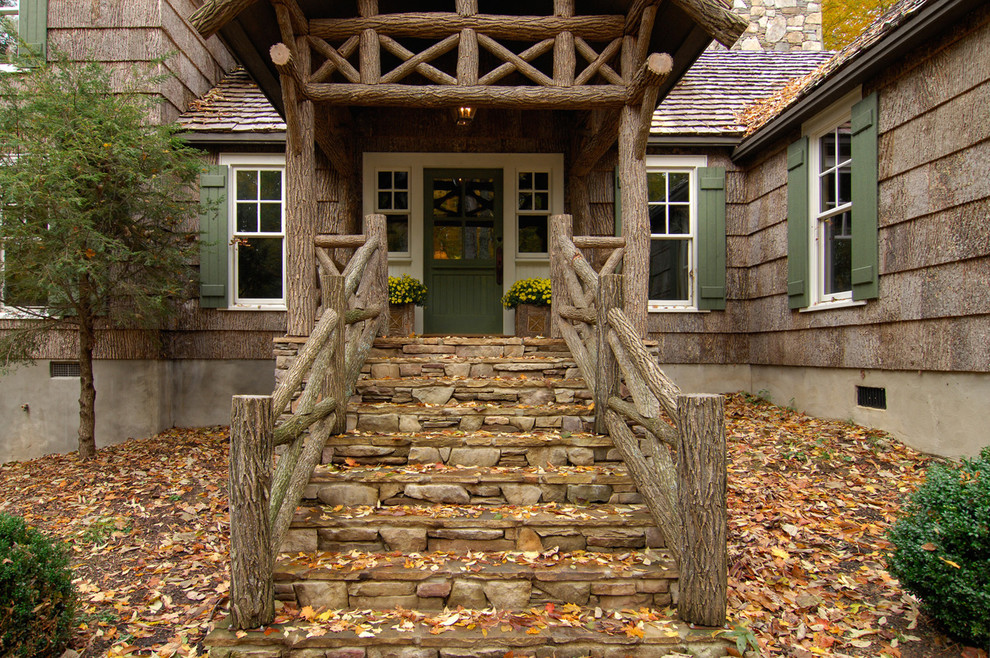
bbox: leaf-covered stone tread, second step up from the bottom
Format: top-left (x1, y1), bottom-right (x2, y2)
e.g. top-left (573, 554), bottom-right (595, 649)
top-left (275, 549), bottom-right (678, 580)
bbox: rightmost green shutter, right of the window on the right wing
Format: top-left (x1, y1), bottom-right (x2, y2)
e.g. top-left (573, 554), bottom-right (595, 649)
top-left (852, 92), bottom-right (879, 300)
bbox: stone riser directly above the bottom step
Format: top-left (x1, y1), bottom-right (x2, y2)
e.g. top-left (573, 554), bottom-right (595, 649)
top-left (275, 570), bottom-right (676, 612)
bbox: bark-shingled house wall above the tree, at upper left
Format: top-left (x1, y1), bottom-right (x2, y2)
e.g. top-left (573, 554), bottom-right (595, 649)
top-left (48, 0), bottom-right (235, 122)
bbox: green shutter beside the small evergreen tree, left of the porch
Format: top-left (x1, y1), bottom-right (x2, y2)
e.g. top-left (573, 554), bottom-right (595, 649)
top-left (199, 165), bottom-right (228, 308)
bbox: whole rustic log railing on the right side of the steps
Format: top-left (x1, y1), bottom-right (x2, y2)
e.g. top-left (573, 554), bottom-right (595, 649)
top-left (550, 215), bottom-right (728, 626)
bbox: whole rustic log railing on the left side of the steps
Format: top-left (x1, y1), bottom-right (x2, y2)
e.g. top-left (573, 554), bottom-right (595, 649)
top-left (229, 215), bottom-right (388, 629)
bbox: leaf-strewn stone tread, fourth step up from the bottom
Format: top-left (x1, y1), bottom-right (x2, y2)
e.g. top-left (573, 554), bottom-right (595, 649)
top-left (310, 464), bottom-right (633, 486)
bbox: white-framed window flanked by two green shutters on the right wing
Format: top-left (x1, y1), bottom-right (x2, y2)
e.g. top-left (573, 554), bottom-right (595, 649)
top-left (810, 120), bottom-right (853, 303)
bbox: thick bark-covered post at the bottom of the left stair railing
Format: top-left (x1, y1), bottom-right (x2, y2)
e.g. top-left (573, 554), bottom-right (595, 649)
top-left (229, 395), bottom-right (275, 630)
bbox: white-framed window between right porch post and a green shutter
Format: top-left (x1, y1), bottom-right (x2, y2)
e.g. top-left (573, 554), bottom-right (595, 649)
top-left (646, 169), bottom-right (697, 308)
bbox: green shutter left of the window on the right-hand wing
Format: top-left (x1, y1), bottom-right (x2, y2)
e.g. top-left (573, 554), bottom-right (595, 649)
top-left (787, 137), bottom-right (811, 308)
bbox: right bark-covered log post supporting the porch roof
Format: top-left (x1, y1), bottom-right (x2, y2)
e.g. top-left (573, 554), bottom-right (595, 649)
top-left (618, 36), bottom-right (650, 338)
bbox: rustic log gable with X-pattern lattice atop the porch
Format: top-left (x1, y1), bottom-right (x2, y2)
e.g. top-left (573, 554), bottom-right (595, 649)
top-left (192, 0), bottom-right (745, 116)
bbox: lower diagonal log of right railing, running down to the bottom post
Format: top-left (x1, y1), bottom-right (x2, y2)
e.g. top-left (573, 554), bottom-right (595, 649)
top-left (605, 410), bottom-right (682, 561)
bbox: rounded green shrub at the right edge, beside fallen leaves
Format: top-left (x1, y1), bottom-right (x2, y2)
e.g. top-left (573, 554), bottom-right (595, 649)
top-left (887, 447), bottom-right (990, 647)
